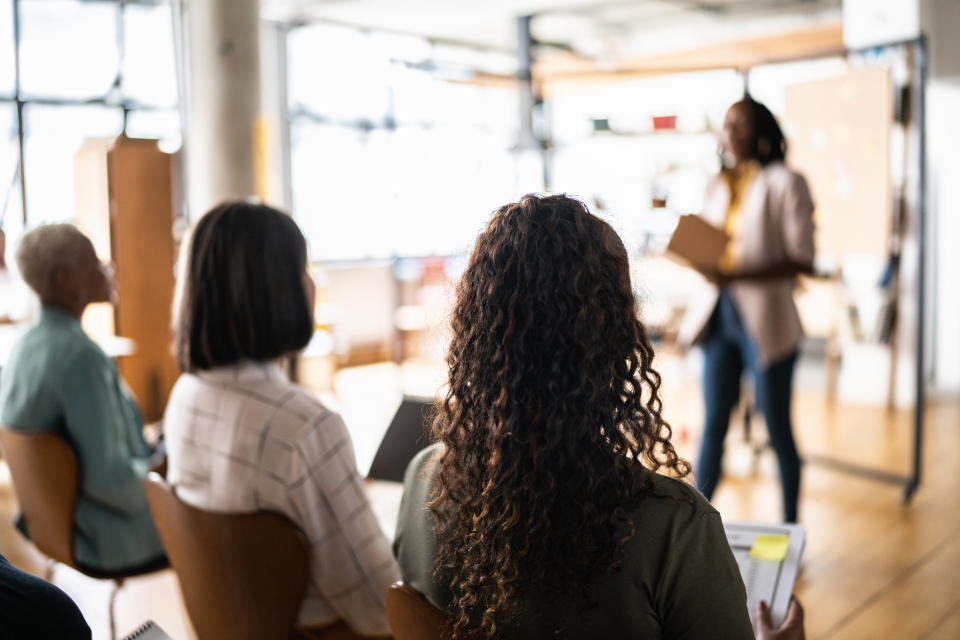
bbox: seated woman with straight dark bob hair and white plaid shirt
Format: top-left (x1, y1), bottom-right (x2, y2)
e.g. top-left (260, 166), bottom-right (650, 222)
top-left (164, 202), bottom-right (399, 638)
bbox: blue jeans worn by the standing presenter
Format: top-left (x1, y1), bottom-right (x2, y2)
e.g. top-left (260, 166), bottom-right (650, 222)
top-left (697, 291), bottom-right (800, 522)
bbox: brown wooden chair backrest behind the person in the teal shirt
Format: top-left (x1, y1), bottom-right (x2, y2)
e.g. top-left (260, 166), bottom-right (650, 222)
top-left (0, 426), bottom-right (78, 566)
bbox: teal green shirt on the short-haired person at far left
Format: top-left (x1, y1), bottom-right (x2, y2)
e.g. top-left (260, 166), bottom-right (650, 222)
top-left (0, 307), bottom-right (163, 571)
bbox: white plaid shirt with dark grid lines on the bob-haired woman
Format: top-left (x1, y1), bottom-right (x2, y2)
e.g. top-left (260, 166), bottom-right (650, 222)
top-left (164, 362), bottom-right (400, 635)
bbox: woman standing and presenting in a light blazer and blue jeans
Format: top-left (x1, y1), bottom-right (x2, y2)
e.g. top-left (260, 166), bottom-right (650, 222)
top-left (683, 96), bottom-right (814, 522)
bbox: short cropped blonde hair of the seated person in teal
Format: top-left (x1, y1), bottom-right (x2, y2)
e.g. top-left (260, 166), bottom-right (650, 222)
top-left (17, 224), bottom-right (89, 300)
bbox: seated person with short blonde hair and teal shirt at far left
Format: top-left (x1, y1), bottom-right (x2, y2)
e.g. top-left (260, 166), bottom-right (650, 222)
top-left (0, 224), bottom-right (165, 573)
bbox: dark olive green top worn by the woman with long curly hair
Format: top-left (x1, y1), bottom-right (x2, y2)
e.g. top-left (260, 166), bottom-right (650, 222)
top-left (394, 445), bottom-right (754, 640)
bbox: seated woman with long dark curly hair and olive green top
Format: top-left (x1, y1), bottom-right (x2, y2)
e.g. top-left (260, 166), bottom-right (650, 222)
top-left (394, 195), bottom-right (801, 639)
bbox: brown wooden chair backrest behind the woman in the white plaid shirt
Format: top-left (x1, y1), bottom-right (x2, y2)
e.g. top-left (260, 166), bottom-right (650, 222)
top-left (146, 473), bottom-right (310, 640)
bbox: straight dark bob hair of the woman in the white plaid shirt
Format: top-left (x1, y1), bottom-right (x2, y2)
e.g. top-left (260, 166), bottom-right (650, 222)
top-left (173, 202), bottom-right (313, 371)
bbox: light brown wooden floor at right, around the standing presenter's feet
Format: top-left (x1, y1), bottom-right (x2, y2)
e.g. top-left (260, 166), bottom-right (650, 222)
top-left (714, 402), bottom-right (960, 640)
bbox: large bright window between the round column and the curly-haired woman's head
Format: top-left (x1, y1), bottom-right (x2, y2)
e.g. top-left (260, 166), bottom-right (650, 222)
top-left (287, 24), bottom-right (543, 260)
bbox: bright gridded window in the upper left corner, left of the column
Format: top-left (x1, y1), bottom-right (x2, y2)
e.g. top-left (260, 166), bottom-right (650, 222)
top-left (0, 0), bottom-right (180, 264)
